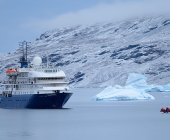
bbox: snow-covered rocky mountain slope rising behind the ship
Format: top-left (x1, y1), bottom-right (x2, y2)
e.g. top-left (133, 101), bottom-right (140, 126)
top-left (0, 16), bottom-right (170, 87)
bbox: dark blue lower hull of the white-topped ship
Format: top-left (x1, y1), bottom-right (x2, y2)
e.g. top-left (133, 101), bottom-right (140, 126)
top-left (0, 93), bottom-right (72, 109)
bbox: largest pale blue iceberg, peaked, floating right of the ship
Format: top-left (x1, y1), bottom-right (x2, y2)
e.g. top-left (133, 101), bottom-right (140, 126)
top-left (96, 73), bottom-right (155, 101)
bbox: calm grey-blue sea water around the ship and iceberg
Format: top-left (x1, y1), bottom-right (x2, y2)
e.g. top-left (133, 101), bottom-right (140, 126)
top-left (0, 89), bottom-right (170, 140)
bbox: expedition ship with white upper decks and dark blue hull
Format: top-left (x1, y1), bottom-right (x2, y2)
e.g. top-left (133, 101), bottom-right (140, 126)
top-left (0, 42), bottom-right (72, 109)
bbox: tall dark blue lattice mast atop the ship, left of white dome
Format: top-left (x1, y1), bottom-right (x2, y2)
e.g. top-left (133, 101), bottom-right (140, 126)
top-left (19, 41), bottom-right (31, 68)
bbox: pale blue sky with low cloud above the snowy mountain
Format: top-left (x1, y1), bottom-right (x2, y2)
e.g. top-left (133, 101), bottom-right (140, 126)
top-left (0, 0), bottom-right (170, 53)
